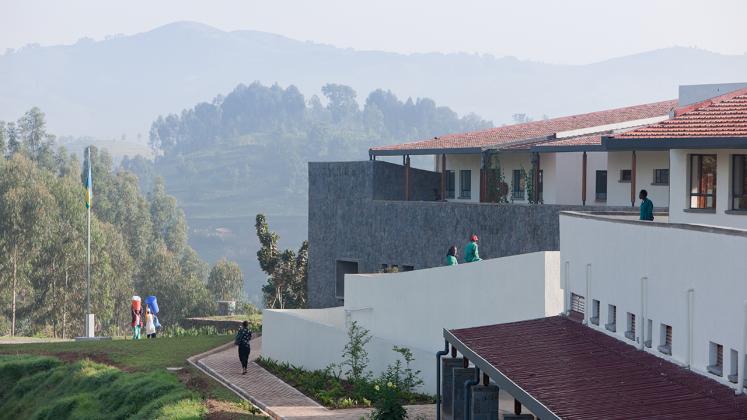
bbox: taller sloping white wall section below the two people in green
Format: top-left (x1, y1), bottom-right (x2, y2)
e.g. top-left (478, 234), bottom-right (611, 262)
top-left (345, 251), bottom-right (562, 349)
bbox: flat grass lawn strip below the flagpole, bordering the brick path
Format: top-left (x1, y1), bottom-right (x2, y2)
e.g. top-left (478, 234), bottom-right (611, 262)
top-left (0, 335), bottom-right (266, 419)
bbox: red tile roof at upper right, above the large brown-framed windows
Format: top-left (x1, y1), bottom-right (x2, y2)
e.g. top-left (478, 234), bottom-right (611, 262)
top-left (611, 89), bottom-right (747, 139)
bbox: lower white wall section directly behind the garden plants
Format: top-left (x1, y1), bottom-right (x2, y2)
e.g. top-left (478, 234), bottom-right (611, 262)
top-left (262, 308), bottom-right (436, 394)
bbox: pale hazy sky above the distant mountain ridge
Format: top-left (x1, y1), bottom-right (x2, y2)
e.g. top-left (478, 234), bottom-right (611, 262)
top-left (0, 0), bottom-right (747, 64)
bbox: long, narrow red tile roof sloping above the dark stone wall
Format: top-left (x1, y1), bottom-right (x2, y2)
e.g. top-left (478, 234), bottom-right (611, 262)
top-left (370, 100), bottom-right (677, 155)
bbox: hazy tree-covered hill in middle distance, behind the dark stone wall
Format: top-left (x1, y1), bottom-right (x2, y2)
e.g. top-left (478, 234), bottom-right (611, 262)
top-left (136, 83), bottom-right (491, 297)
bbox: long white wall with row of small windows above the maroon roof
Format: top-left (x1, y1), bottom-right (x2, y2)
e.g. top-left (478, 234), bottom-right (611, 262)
top-left (560, 214), bottom-right (747, 390)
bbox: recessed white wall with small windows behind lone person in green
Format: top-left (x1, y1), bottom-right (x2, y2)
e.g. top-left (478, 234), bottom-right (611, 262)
top-left (608, 151), bottom-right (674, 207)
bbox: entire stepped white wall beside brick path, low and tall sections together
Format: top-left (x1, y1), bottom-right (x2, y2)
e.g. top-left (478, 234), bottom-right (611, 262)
top-left (262, 251), bottom-right (563, 393)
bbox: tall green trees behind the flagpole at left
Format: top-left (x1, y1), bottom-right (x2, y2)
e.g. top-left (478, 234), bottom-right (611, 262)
top-left (0, 108), bottom-right (228, 337)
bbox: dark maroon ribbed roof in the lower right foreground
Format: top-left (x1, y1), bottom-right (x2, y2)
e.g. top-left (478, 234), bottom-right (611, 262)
top-left (451, 316), bottom-right (747, 420)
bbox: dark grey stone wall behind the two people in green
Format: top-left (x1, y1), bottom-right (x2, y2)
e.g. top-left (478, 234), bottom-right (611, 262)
top-left (308, 161), bottom-right (636, 308)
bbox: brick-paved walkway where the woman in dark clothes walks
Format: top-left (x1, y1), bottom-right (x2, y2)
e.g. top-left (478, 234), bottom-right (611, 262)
top-left (190, 338), bottom-right (436, 420)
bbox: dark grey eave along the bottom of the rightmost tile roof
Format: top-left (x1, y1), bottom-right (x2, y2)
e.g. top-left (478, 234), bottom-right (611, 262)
top-left (602, 136), bottom-right (747, 150)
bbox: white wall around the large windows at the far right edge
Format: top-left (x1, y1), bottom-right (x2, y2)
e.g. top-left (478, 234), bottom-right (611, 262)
top-left (669, 149), bottom-right (747, 229)
